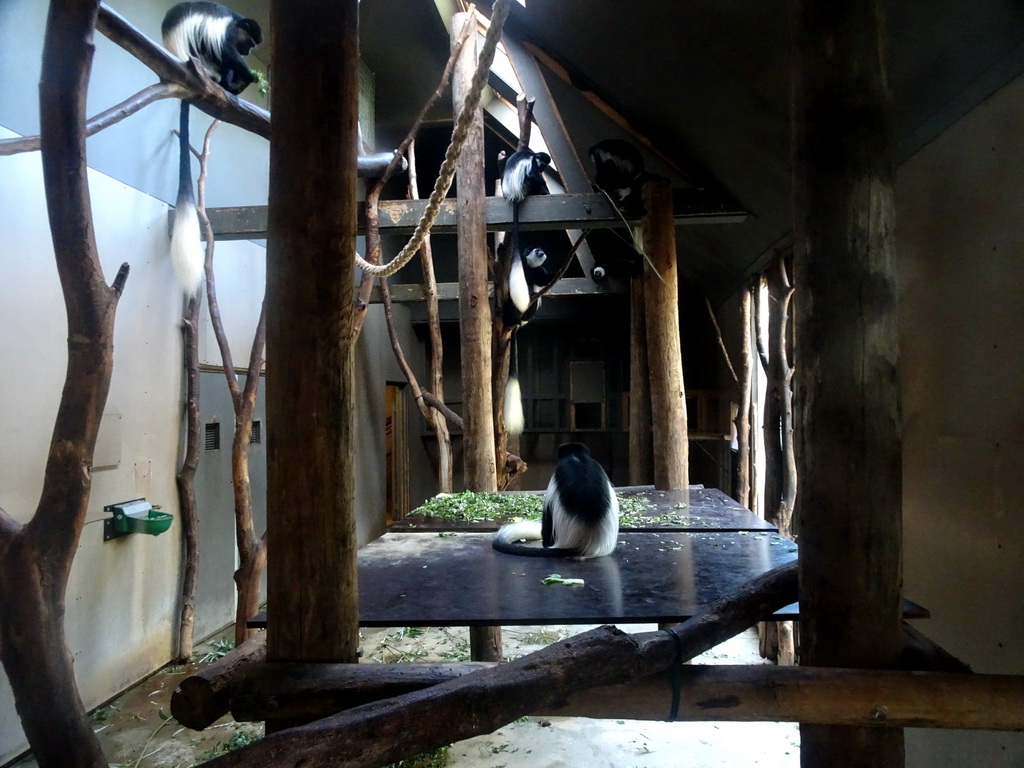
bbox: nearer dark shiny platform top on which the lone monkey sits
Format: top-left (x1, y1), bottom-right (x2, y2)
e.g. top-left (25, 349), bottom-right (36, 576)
top-left (250, 531), bottom-right (797, 627)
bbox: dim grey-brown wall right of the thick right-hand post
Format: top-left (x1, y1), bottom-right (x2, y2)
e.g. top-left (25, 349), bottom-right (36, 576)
top-left (896, 78), bottom-right (1024, 768)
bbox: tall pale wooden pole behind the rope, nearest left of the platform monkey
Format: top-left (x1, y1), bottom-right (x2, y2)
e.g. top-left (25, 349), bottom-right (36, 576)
top-left (452, 13), bottom-right (502, 662)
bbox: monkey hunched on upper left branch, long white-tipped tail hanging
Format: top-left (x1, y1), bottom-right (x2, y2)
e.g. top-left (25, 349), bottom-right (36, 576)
top-left (161, 2), bottom-right (263, 296)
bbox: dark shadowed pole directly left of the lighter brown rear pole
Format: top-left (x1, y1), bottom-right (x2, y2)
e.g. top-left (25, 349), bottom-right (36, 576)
top-left (629, 279), bottom-right (654, 485)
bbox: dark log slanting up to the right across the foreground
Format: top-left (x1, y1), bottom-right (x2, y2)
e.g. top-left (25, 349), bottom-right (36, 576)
top-left (201, 561), bottom-right (798, 768)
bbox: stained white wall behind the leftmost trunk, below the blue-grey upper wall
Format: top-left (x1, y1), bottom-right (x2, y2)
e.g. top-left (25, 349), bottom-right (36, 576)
top-left (0, 129), bottom-right (181, 762)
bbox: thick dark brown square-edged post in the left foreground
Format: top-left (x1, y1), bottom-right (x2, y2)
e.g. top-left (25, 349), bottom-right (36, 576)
top-left (266, 0), bottom-right (359, 662)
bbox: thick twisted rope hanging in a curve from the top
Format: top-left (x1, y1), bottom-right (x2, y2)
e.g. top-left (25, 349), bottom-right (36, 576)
top-left (355, 0), bottom-right (510, 278)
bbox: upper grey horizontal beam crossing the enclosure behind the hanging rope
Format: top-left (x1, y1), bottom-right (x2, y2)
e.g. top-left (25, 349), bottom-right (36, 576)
top-left (199, 188), bottom-right (750, 240)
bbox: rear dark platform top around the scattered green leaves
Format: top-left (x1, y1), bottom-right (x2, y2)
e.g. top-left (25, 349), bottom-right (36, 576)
top-left (388, 485), bottom-right (777, 532)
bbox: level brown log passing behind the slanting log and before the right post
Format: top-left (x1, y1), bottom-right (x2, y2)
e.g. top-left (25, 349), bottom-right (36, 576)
top-left (230, 662), bottom-right (1024, 731)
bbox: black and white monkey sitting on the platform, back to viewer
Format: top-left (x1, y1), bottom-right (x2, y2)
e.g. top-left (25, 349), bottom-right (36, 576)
top-left (492, 442), bottom-right (618, 560)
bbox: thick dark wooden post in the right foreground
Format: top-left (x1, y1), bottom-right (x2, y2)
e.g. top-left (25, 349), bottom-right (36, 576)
top-left (794, 0), bottom-right (903, 768)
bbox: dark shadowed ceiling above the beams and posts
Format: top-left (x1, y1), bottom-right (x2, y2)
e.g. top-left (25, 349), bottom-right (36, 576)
top-left (360, 0), bottom-right (1024, 301)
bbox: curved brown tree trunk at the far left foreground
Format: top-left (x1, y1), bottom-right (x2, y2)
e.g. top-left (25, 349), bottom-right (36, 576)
top-left (0, 0), bottom-right (128, 768)
